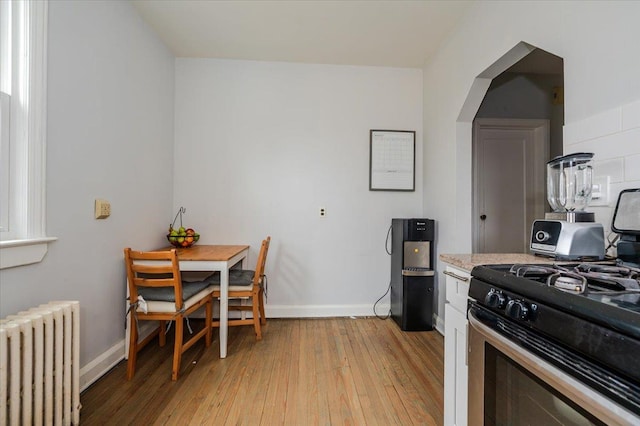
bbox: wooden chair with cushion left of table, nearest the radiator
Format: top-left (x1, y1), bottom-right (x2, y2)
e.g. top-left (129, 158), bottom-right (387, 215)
top-left (124, 248), bottom-right (213, 381)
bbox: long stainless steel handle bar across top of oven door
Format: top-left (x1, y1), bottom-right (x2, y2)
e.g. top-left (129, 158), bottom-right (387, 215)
top-left (468, 309), bottom-right (638, 425)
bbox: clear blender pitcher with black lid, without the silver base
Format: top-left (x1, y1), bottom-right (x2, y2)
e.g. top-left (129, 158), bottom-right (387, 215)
top-left (547, 152), bottom-right (593, 212)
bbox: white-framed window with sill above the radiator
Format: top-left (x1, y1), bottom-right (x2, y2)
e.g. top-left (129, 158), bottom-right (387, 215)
top-left (0, 0), bottom-right (55, 269)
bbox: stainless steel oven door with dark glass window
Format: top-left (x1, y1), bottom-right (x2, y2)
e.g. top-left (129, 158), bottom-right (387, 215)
top-left (468, 304), bottom-right (640, 425)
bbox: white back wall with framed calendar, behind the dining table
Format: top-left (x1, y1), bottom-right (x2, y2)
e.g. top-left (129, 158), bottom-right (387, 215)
top-left (174, 59), bottom-right (423, 316)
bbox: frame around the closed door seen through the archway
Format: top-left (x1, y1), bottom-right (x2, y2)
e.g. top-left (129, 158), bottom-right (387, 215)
top-left (471, 118), bottom-right (550, 253)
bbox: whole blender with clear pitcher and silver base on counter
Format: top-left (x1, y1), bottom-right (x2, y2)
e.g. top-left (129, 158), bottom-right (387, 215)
top-left (530, 152), bottom-right (604, 261)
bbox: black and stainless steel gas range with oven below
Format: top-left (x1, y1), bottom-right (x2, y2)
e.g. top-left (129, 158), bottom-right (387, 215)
top-left (467, 188), bottom-right (640, 425)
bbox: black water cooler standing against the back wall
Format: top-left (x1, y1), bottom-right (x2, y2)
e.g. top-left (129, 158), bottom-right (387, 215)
top-left (391, 219), bottom-right (435, 331)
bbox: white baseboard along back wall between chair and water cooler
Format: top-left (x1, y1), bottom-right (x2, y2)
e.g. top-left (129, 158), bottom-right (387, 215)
top-left (265, 303), bottom-right (389, 318)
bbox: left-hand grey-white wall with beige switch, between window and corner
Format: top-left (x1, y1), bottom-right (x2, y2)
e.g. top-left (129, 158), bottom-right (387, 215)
top-left (0, 1), bottom-right (174, 386)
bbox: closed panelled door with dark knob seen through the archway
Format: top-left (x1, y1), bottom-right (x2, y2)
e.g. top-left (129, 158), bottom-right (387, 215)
top-left (473, 119), bottom-right (549, 253)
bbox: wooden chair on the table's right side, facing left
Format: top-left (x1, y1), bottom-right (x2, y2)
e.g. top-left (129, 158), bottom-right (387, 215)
top-left (211, 237), bottom-right (271, 340)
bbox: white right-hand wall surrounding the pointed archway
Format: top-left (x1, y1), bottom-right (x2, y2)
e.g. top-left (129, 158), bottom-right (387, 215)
top-left (424, 1), bottom-right (640, 318)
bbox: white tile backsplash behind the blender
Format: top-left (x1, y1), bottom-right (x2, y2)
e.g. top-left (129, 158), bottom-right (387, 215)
top-left (564, 100), bottom-right (640, 255)
